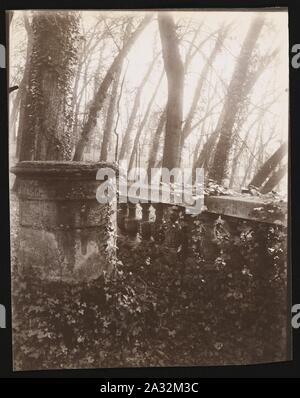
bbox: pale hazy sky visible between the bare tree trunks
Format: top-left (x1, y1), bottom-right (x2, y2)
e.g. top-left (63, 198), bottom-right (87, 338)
top-left (10, 10), bottom-right (288, 193)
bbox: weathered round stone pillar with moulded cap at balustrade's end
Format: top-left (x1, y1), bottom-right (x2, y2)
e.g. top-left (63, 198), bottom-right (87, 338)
top-left (12, 161), bottom-right (116, 283)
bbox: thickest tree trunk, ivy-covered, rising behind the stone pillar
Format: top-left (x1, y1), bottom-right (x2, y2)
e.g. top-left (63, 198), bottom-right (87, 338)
top-left (24, 11), bottom-right (79, 160)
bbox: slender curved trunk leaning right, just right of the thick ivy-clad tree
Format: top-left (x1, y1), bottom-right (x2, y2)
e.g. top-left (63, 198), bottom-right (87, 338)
top-left (73, 15), bottom-right (151, 160)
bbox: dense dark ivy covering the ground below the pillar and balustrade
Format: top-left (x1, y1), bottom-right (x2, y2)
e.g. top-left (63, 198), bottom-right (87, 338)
top-left (13, 205), bottom-right (287, 369)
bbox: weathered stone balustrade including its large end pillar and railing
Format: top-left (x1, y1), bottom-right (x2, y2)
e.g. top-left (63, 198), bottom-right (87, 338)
top-left (12, 161), bottom-right (287, 283)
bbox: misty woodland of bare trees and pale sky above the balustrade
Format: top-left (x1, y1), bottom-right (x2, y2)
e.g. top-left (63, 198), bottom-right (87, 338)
top-left (10, 11), bottom-right (288, 193)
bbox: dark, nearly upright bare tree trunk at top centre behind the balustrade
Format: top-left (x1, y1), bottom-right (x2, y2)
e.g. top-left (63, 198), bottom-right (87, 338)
top-left (158, 13), bottom-right (184, 170)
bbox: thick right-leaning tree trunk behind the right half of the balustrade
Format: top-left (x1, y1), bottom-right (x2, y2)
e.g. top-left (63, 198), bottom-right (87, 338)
top-left (209, 17), bottom-right (264, 183)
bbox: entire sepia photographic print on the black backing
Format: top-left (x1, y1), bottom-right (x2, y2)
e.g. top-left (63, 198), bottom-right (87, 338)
top-left (7, 8), bottom-right (291, 371)
